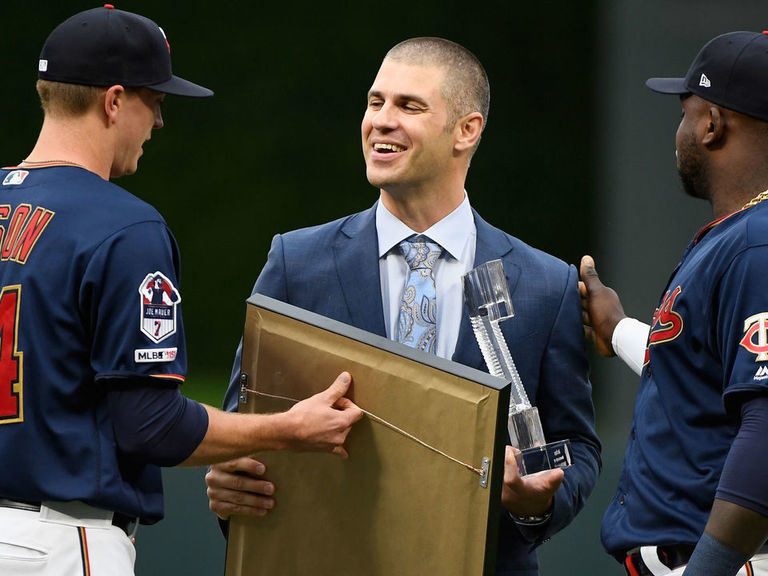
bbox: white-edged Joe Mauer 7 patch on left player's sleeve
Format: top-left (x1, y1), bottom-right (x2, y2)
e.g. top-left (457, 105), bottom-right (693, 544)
top-left (139, 271), bottom-right (181, 343)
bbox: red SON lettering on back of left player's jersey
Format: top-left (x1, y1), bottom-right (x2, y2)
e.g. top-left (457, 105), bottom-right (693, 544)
top-left (0, 204), bottom-right (54, 264)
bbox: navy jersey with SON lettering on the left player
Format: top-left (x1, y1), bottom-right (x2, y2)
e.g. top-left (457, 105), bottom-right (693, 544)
top-left (0, 166), bottom-right (186, 522)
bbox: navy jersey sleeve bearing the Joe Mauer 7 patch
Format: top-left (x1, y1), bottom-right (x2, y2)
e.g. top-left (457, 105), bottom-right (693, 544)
top-left (79, 221), bottom-right (186, 386)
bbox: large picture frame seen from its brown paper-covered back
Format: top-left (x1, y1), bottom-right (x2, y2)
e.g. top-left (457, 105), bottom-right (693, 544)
top-left (226, 295), bottom-right (509, 576)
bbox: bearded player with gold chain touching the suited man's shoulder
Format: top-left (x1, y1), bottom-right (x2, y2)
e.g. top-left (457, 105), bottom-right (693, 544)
top-left (580, 32), bottom-right (768, 576)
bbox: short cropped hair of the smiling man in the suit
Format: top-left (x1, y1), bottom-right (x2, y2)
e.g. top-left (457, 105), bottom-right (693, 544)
top-left (384, 36), bottom-right (491, 132)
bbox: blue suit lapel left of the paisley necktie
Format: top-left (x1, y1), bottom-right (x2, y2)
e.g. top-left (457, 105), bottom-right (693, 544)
top-left (333, 205), bottom-right (386, 336)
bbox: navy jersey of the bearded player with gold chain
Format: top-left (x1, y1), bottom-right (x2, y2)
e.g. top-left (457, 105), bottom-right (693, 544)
top-left (602, 202), bottom-right (768, 561)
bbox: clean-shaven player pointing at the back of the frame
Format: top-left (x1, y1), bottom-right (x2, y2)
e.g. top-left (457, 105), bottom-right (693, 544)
top-left (0, 5), bottom-right (362, 575)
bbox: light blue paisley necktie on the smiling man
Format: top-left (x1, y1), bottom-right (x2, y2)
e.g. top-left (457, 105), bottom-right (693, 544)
top-left (397, 235), bottom-right (443, 354)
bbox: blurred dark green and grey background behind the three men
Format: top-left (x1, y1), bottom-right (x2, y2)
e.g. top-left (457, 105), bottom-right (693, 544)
top-left (0, 0), bottom-right (768, 576)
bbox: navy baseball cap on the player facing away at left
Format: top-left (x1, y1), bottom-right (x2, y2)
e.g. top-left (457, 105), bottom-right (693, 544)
top-left (38, 4), bottom-right (213, 97)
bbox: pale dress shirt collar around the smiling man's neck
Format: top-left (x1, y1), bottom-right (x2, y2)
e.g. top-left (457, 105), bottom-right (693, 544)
top-left (376, 192), bottom-right (475, 260)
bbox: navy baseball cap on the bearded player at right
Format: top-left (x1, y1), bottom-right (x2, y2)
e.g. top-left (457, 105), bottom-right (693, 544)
top-left (645, 32), bottom-right (768, 122)
